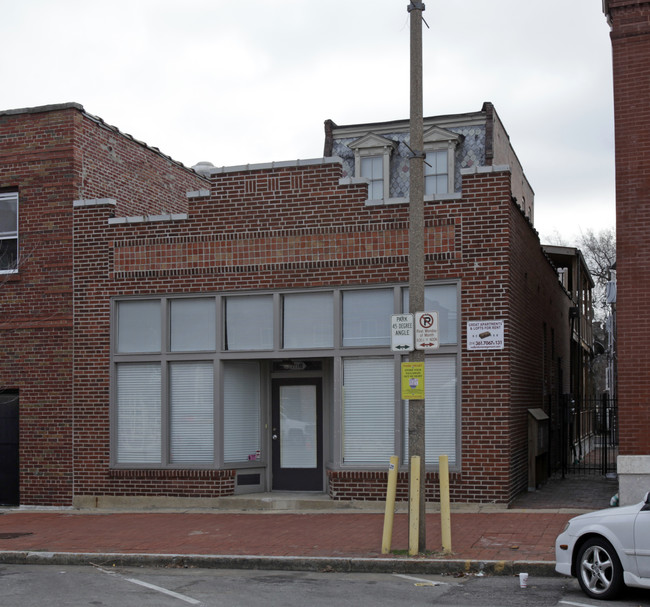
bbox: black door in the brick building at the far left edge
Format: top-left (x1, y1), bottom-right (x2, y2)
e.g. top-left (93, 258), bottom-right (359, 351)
top-left (0, 392), bottom-right (20, 506)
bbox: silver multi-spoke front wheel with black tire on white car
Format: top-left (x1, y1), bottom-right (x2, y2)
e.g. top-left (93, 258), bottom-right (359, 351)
top-left (576, 537), bottom-right (623, 599)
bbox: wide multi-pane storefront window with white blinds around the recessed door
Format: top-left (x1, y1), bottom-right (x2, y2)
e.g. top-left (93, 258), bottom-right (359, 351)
top-left (111, 284), bottom-right (458, 468)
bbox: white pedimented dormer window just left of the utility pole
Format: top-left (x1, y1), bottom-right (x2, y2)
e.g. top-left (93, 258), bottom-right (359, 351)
top-left (350, 133), bottom-right (397, 200)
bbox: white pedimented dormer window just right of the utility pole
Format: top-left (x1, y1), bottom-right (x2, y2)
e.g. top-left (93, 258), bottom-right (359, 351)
top-left (424, 126), bottom-right (463, 196)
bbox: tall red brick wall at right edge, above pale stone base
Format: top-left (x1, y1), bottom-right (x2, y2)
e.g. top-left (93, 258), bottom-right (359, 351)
top-left (609, 0), bottom-right (650, 455)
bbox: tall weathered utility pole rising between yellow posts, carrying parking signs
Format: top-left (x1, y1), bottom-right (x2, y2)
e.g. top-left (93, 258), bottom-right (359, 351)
top-left (408, 1), bottom-right (426, 552)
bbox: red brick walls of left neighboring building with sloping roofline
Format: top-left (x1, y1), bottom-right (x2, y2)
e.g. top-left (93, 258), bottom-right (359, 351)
top-left (0, 106), bottom-right (206, 505)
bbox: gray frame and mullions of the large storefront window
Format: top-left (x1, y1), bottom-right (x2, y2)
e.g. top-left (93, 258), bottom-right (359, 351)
top-left (110, 279), bottom-right (462, 469)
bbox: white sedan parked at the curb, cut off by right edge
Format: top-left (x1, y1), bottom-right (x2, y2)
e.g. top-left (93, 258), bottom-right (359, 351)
top-left (555, 492), bottom-right (650, 599)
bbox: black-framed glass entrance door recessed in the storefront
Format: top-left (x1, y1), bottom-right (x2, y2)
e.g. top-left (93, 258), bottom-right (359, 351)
top-left (271, 378), bottom-right (323, 491)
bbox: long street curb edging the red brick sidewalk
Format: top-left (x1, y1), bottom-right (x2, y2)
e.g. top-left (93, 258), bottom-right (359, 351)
top-left (0, 551), bottom-right (557, 577)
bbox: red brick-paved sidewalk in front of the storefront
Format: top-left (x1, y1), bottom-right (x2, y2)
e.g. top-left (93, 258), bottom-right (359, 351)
top-left (0, 504), bottom-right (581, 575)
